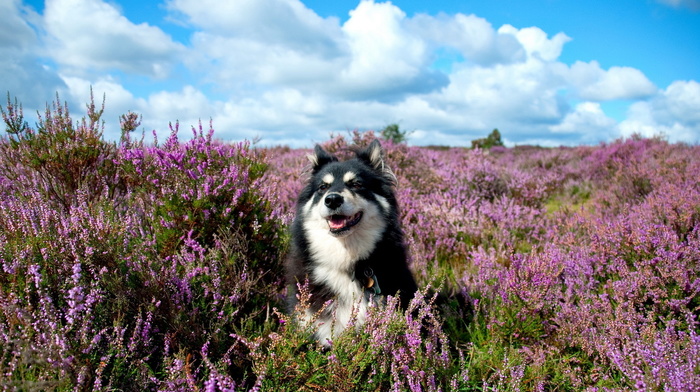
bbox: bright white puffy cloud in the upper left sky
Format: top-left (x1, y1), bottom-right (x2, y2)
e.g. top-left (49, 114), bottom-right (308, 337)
top-left (44, 0), bottom-right (184, 78)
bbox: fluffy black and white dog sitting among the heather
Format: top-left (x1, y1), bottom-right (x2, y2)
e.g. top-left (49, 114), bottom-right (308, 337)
top-left (285, 140), bottom-right (417, 346)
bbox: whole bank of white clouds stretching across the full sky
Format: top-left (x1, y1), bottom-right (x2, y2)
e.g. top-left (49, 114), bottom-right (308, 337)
top-left (0, 0), bottom-right (700, 146)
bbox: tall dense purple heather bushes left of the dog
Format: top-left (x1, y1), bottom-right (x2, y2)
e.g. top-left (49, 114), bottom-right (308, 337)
top-left (0, 96), bottom-right (284, 390)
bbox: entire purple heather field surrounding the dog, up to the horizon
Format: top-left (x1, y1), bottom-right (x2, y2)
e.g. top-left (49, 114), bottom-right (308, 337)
top-left (0, 95), bottom-right (700, 391)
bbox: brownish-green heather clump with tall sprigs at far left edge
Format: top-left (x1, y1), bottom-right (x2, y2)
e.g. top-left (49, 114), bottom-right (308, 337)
top-left (0, 90), bottom-right (124, 211)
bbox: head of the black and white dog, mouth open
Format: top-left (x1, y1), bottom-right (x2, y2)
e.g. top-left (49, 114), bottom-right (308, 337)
top-left (302, 140), bottom-right (396, 237)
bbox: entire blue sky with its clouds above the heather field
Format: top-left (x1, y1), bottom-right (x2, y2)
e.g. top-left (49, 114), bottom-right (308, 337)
top-left (0, 0), bottom-right (700, 147)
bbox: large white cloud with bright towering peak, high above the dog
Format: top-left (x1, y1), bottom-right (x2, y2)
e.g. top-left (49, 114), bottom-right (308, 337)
top-left (178, 0), bottom-right (447, 100)
